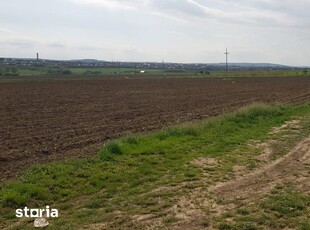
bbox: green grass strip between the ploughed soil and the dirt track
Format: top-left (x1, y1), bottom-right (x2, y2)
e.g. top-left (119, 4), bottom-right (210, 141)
top-left (0, 104), bottom-right (310, 229)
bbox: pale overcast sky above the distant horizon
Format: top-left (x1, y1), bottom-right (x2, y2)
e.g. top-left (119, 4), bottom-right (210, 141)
top-left (0, 0), bottom-right (310, 66)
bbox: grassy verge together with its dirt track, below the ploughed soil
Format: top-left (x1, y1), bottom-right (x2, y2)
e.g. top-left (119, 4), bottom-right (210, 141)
top-left (0, 103), bottom-right (310, 230)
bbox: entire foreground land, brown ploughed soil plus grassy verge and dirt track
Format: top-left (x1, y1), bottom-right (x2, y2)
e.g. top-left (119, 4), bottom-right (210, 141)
top-left (0, 77), bottom-right (310, 230)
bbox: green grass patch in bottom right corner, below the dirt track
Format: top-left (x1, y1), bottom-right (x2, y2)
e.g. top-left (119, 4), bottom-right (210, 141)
top-left (219, 184), bottom-right (310, 230)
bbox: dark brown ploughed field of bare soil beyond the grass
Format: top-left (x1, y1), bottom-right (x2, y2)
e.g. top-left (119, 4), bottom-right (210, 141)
top-left (0, 78), bottom-right (310, 180)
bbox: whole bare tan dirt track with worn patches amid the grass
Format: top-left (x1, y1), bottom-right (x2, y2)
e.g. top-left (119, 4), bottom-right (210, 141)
top-left (136, 120), bottom-right (310, 229)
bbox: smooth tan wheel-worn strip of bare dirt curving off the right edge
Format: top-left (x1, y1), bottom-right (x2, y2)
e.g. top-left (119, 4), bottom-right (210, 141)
top-left (214, 137), bottom-right (310, 201)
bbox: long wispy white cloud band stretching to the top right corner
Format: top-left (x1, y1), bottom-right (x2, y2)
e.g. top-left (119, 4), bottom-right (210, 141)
top-left (71, 0), bottom-right (304, 26)
